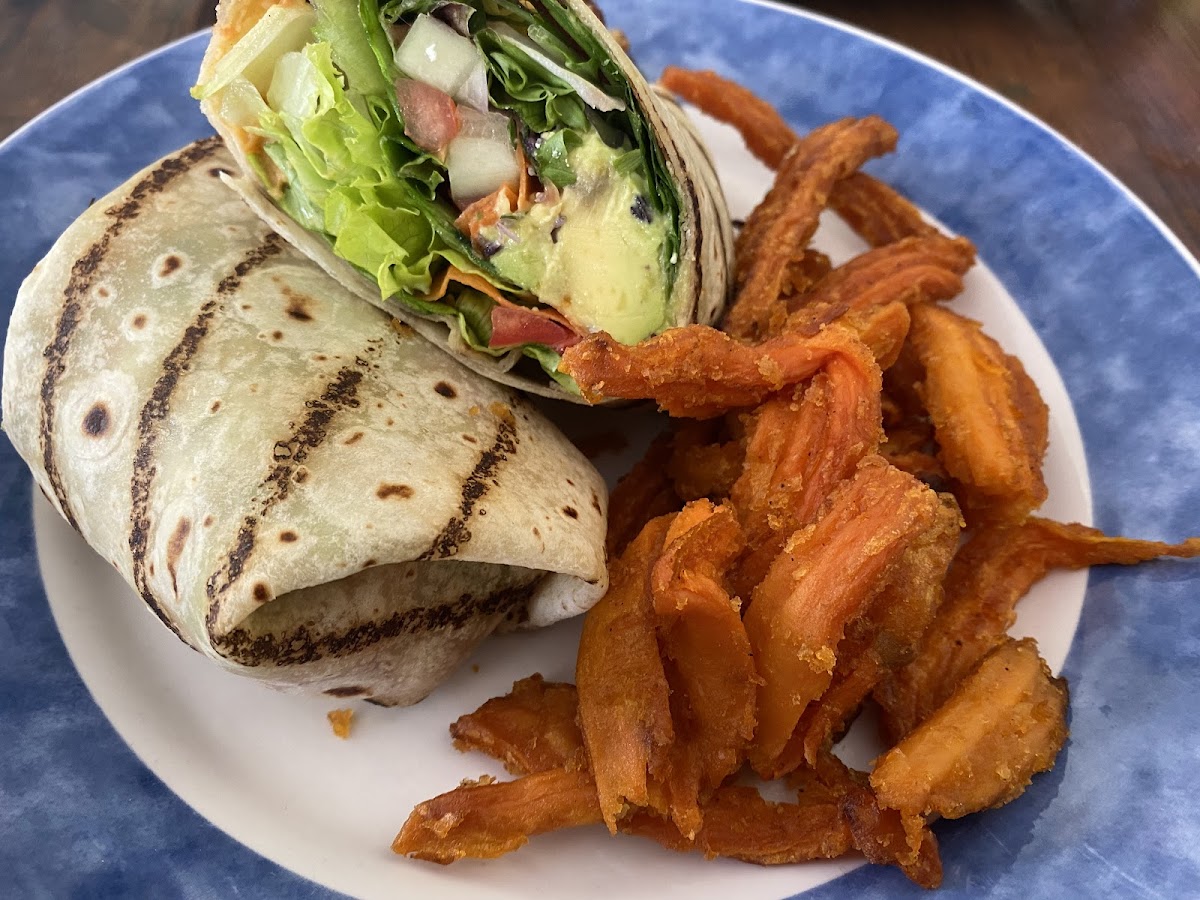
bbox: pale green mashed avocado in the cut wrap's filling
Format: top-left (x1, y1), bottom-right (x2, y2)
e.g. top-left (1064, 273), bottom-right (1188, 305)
top-left (481, 133), bottom-right (670, 343)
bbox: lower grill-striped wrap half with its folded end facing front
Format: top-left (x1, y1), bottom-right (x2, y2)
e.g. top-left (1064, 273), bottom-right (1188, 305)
top-left (2, 138), bottom-right (606, 706)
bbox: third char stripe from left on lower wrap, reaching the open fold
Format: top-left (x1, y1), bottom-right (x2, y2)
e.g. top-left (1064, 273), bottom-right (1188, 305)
top-left (205, 352), bottom-right (377, 638)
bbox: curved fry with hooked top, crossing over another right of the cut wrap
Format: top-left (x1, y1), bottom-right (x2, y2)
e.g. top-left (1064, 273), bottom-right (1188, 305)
top-left (724, 116), bottom-right (896, 340)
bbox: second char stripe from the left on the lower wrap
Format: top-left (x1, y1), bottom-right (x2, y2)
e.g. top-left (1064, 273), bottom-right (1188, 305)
top-left (130, 234), bottom-right (284, 640)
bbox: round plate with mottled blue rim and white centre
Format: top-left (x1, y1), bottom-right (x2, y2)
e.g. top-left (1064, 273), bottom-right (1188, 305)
top-left (0, 0), bottom-right (1200, 898)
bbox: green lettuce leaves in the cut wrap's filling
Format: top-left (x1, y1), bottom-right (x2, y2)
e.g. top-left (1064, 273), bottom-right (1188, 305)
top-left (194, 0), bottom-right (680, 390)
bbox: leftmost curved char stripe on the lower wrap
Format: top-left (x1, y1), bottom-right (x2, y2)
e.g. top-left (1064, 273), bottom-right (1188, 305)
top-left (38, 137), bottom-right (222, 528)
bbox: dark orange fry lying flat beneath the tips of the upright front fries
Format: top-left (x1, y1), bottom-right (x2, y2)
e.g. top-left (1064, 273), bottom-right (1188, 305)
top-left (625, 785), bottom-right (853, 865)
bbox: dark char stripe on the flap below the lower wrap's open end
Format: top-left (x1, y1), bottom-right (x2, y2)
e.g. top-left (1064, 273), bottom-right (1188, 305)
top-left (214, 574), bottom-right (545, 672)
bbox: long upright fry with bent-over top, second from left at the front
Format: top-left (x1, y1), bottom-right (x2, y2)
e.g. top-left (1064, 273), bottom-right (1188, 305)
top-left (650, 500), bottom-right (757, 838)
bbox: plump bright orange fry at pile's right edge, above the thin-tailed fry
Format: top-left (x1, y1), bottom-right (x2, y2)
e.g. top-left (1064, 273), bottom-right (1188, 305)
top-left (911, 305), bottom-right (1049, 520)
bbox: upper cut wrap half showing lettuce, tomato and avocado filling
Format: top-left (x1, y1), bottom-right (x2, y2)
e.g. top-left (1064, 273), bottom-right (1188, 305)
top-left (193, 0), bottom-right (732, 400)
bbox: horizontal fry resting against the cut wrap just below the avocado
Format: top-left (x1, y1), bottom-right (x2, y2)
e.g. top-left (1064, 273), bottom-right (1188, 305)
top-left (559, 325), bottom-right (878, 419)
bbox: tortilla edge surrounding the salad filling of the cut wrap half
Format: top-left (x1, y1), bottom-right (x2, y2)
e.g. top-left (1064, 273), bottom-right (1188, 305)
top-left (198, 0), bottom-right (733, 403)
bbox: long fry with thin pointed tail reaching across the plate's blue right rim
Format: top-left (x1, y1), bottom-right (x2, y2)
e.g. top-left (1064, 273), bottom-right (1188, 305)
top-left (875, 518), bottom-right (1200, 746)
